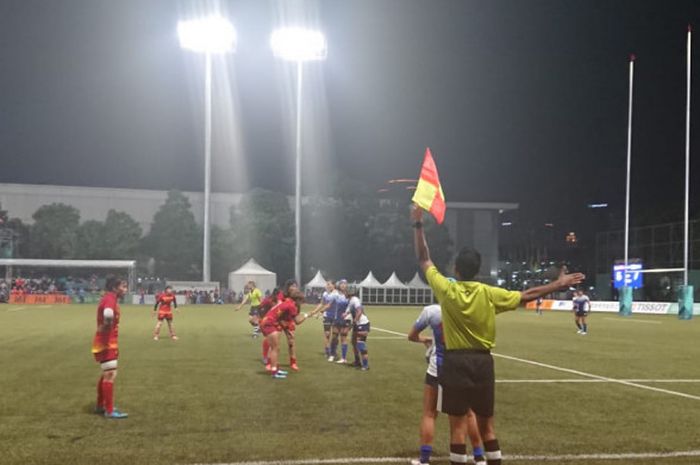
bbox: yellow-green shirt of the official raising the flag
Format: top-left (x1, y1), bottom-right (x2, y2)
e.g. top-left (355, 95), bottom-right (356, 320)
top-left (425, 266), bottom-right (520, 350)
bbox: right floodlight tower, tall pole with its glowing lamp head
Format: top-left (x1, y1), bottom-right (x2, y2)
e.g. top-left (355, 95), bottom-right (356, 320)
top-left (270, 28), bottom-right (328, 285)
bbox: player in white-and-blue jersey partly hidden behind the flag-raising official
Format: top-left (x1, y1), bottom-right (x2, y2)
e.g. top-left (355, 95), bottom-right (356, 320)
top-left (408, 304), bottom-right (486, 465)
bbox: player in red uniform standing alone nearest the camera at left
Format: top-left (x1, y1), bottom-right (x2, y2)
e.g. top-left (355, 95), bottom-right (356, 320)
top-left (92, 276), bottom-right (128, 419)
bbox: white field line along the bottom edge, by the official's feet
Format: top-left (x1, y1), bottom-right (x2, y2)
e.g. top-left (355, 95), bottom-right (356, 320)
top-left (191, 450), bottom-right (700, 465)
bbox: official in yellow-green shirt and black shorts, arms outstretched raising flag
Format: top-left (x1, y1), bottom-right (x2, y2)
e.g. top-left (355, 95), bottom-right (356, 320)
top-left (411, 205), bottom-right (585, 465)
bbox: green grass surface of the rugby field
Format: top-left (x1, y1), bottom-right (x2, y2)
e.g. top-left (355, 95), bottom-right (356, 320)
top-left (0, 305), bottom-right (700, 465)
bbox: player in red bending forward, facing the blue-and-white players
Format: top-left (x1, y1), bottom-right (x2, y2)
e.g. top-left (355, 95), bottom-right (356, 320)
top-left (260, 289), bottom-right (320, 378)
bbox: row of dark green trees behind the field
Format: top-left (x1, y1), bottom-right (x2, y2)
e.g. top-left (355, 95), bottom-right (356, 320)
top-left (0, 189), bottom-right (452, 283)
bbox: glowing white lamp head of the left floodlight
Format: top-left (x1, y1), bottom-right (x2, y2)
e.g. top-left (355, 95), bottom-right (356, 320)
top-left (177, 15), bottom-right (237, 54)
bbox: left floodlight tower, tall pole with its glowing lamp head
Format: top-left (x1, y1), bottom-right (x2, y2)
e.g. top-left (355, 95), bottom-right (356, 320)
top-left (177, 15), bottom-right (236, 282)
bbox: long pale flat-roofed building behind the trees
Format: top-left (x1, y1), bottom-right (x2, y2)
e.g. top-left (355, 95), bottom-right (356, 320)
top-left (0, 183), bottom-right (518, 279)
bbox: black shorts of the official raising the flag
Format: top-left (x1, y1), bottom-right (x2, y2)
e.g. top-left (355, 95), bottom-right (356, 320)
top-left (438, 349), bottom-right (496, 417)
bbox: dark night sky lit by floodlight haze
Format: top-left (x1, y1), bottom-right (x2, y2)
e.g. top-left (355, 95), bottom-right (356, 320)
top-left (0, 0), bottom-right (700, 229)
